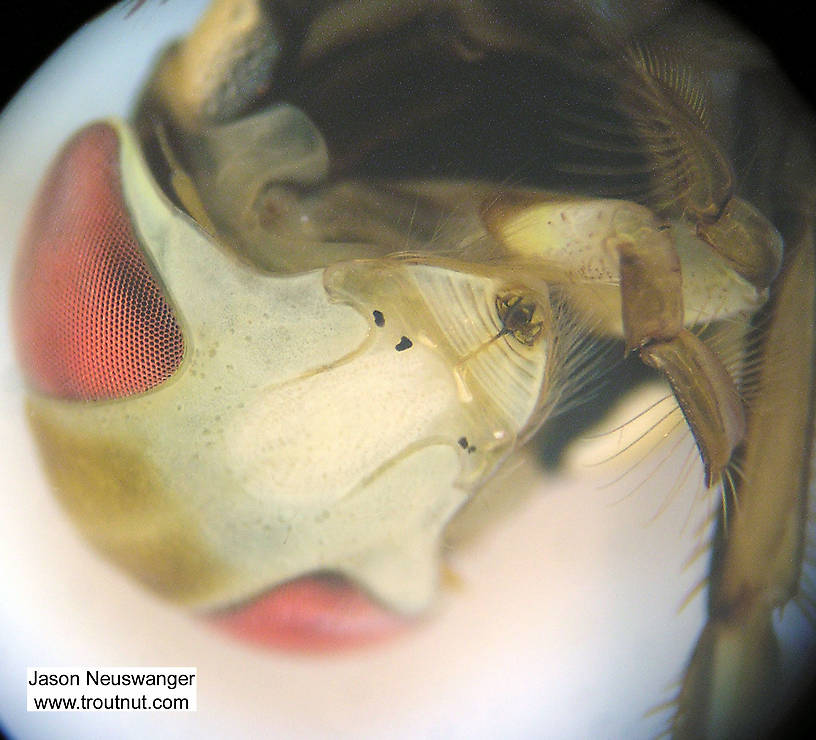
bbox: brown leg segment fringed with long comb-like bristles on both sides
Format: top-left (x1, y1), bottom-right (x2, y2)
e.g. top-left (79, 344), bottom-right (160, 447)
top-left (553, 44), bottom-right (734, 218)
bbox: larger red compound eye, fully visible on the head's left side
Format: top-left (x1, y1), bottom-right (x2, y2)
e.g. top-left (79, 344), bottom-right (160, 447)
top-left (13, 124), bottom-right (184, 401)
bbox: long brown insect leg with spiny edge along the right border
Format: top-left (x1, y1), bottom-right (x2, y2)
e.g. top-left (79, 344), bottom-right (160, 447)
top-left (673, 204), bottom-right (816, 737)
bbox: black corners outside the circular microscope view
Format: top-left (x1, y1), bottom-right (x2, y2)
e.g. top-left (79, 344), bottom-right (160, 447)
top-left (0, 0), bottom-right (816, 737)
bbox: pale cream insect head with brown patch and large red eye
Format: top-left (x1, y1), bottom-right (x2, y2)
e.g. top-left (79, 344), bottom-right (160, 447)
top-left (13, 115), bottom-right (554, 642)
